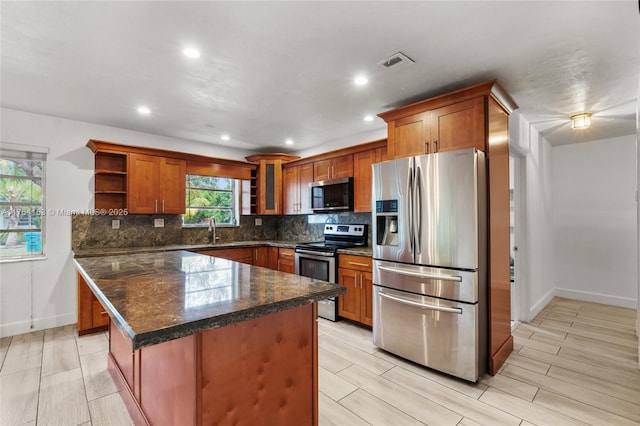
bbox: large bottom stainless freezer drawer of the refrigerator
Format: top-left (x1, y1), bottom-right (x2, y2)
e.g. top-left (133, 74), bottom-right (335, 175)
top-left (373, 285), bottom-right (483, 382)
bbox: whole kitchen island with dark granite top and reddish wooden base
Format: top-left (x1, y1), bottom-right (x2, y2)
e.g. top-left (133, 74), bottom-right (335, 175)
top-left (75, 251), bottom-right (344, 425)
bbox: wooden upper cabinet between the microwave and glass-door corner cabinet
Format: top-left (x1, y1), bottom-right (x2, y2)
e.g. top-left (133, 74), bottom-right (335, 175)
top-left (282, 163), bottom-right (313, 214)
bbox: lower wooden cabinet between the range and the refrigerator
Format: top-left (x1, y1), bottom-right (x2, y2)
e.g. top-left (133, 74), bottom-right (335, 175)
top-left (338, 254), bottom-right (373, 326)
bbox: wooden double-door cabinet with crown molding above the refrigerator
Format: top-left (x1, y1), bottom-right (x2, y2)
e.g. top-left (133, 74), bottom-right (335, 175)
top-left (379, 81), bottom-right (515, 158)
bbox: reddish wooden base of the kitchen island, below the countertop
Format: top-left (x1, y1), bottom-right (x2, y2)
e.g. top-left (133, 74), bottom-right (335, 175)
top-left (109, 303), bottom-right (318, 425)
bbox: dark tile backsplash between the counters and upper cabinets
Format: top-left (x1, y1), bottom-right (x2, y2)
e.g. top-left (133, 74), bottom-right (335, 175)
top-left (71, 213), bottom-right (371, 250)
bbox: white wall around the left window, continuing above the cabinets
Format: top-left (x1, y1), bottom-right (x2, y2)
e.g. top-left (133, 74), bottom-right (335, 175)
top-left (0, 108), bottom-right (255, 337)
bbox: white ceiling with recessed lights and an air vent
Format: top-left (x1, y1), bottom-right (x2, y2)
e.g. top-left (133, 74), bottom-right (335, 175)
top-left (0, 0), bottom-right (640, 152)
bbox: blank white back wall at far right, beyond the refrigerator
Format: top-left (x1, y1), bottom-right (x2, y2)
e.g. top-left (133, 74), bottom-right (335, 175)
top-left (552, 135), bottom-right (638, 308)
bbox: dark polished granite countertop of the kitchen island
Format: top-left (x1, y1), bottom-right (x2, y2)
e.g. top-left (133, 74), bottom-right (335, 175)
top-left (74, 250), bottom-right (345, 350)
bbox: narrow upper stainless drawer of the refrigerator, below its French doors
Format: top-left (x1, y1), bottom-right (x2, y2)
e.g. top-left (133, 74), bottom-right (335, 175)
top-left (373, 260), bottom-right (480, 303)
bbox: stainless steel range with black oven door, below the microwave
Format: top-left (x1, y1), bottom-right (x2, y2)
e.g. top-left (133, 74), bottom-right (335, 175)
top-left (295, 223), bottom-right (368, 321)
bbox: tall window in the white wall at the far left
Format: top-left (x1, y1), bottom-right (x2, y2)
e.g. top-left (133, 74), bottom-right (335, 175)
top-left (0, 144), bottom-right (46, 261)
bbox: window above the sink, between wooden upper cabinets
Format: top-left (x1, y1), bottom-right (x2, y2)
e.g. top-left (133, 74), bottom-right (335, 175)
top-left (182, 175), bottom-right (240, 226)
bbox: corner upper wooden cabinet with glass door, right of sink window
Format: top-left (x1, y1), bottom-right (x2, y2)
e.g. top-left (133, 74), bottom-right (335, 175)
top-left (246, 153), bottom-right (300, 215)
